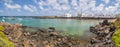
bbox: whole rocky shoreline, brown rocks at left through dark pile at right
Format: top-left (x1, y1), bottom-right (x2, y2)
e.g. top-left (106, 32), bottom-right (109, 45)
top-left (0, 19), bottom-right (115, 47)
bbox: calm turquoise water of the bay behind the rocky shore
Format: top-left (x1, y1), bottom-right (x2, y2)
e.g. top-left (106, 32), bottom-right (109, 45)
top-left (0, 18), bottom-right (102, 36)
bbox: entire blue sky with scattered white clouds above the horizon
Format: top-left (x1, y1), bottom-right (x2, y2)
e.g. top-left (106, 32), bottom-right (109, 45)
top-left (0, 0), bottom-right (120, 16)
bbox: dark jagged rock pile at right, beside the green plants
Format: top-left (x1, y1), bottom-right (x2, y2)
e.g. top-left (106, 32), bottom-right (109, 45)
top-left (90, 20), bottom-right (116, 47)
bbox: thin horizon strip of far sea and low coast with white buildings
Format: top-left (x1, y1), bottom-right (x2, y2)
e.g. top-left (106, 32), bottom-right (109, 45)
top-left (0, 14), bottom-right (120, 19)
